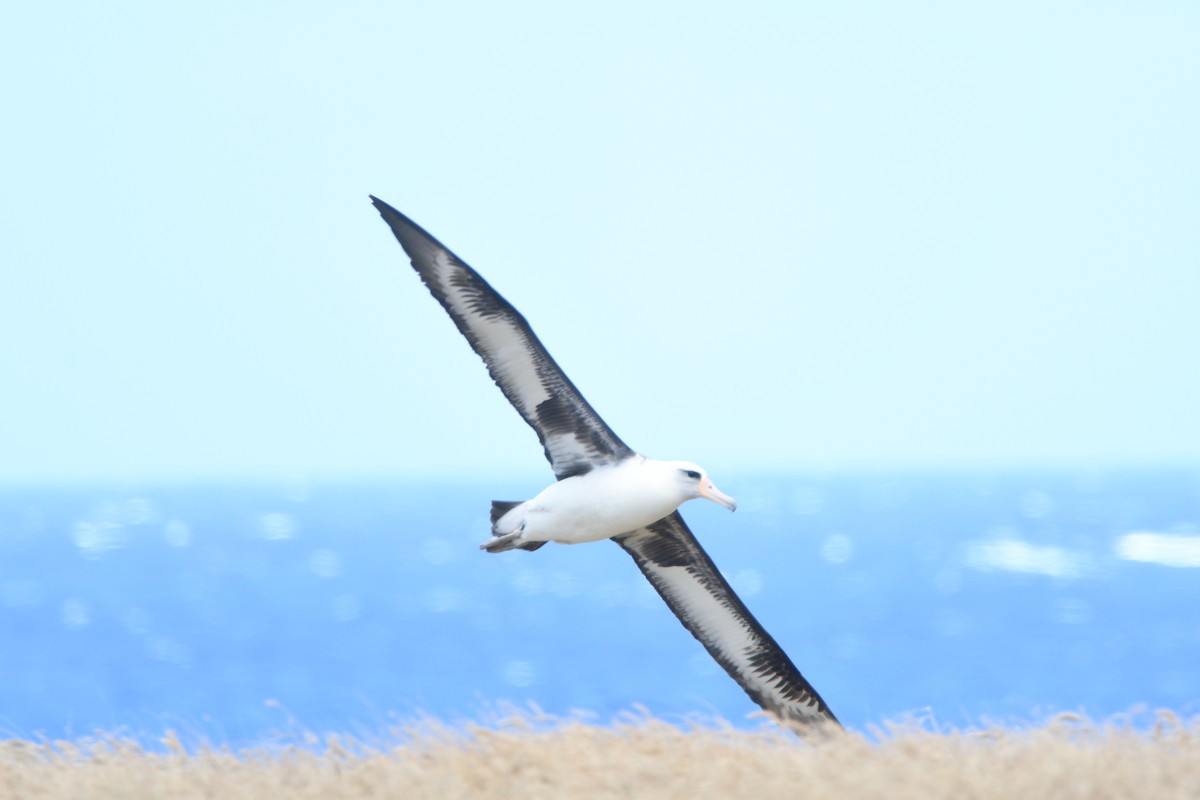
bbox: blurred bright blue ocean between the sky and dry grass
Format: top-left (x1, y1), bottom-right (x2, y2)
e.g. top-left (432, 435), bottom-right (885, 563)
top-left (0, 469), bottom-right (1200, 745)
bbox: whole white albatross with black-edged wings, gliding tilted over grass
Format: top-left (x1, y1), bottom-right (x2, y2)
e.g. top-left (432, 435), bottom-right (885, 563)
top-left (371, 196), bottom-right (838, 726)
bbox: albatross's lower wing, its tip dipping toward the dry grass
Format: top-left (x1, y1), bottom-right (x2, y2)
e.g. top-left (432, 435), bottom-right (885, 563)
top-left (613, 512), bottom-right (838, 724)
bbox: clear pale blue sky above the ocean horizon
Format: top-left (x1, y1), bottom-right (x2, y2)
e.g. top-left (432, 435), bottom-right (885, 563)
top-left (0, 1), bottom-right (1200, 481)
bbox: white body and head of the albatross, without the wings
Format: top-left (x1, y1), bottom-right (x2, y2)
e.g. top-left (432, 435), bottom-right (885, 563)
top-left (485, 456), bottom-right (733, 547)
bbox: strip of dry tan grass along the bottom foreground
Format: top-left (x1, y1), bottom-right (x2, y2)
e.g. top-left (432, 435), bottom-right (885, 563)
top-left (0, 711), bottom-right (1200, 800)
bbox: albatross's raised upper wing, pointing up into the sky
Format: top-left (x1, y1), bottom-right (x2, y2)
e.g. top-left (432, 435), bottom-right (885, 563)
top-left (371, 197), bottom-right (634, 480)
